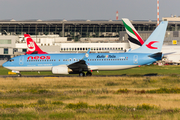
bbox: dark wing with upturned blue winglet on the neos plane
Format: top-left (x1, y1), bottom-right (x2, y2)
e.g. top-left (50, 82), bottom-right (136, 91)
top-left (67, 49), bottom-right (90, 71)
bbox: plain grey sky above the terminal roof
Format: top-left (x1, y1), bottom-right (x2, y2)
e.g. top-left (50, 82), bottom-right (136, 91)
top-left (0, 0), bottom-right (180, 20)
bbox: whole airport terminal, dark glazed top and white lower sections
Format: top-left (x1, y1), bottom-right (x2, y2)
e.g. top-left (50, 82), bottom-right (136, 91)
top-left (0, 20), bottom-right (180, 59)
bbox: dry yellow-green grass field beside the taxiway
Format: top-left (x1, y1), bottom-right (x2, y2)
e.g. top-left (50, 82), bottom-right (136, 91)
top-left (0, 65), bottom-right (180, 120)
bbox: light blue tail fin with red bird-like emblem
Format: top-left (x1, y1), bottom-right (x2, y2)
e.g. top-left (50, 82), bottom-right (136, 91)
top-left (129, 21), bottom-right (168, 53)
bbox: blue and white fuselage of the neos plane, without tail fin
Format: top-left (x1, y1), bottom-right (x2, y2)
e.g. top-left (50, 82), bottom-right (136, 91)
top-left (3, 53), bottom-right (161, 71)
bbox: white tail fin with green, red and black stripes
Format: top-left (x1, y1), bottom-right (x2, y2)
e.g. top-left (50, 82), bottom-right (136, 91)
top-left (122, 18), bottom-right (144, 50)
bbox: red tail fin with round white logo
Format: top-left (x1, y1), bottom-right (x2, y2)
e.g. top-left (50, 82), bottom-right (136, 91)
top-left (24, 34), bottom-right (48, 54)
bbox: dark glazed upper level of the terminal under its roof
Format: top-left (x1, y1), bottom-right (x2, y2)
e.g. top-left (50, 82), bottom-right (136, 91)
top-left (0, 20), bottom-right (180, 38)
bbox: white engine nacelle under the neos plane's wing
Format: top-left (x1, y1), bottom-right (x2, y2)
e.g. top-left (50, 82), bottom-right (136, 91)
top-left (52, 65), bottom-right (71, 74)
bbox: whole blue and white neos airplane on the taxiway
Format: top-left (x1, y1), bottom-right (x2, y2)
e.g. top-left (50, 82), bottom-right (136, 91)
top-left (3, 21), bottom-right (168, 76)
